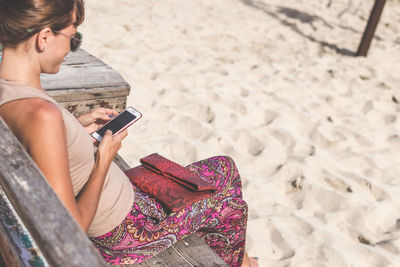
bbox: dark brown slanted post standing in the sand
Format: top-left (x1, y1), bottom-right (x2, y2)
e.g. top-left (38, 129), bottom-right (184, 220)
top-left (356, 0), bottom-right (386, 57)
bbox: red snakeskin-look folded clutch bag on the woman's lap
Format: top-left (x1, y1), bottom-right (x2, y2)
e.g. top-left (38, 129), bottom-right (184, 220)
top-left (125, 153), bottom-right (217, 212)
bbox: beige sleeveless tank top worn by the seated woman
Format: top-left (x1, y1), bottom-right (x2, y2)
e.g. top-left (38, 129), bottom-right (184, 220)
top-left (0, 79), bottom-right (134, 237)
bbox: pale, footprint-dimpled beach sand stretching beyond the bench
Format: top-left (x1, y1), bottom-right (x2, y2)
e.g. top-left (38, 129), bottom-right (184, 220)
top-left (80, 0), bottom-right (400, 267)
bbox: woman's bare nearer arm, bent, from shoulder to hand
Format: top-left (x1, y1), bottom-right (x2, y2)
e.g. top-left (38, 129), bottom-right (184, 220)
top-left (23, 101), bottom-right (127, 231)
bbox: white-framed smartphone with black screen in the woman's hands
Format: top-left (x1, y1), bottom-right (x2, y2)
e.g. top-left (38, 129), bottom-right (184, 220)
top-left (92, 107), bottom-right (142, 142)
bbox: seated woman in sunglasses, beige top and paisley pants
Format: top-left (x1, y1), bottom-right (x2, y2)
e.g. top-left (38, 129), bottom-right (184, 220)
top-left (0, 0), bottom-right (257, 266)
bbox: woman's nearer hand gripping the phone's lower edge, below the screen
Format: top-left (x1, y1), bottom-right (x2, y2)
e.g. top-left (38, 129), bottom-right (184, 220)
top-left (97, 129), bottom-right (128, 165)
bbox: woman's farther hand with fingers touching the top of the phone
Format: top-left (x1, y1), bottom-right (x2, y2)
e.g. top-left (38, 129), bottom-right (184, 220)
top-left (78, 108), bottom-right (118, 134)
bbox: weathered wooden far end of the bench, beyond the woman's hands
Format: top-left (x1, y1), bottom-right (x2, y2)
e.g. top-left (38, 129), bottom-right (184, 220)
top-left (41, 50), bottom-right (130, 116)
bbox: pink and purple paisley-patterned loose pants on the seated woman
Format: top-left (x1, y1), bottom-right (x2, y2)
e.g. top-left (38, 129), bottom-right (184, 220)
top-left (91, 156), bottom-right (247, 266)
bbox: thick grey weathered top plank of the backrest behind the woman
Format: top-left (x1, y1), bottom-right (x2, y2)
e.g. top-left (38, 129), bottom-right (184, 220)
top-left (0, 118), bottom-right (105, 267)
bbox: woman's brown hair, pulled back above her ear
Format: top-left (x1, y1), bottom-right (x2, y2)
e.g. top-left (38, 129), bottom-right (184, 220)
top-left (0, 0), bottom-right (85, 47)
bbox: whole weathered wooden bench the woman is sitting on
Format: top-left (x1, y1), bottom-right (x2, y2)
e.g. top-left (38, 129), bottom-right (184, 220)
top-left (0, 51), bottom-right (227, 266)
